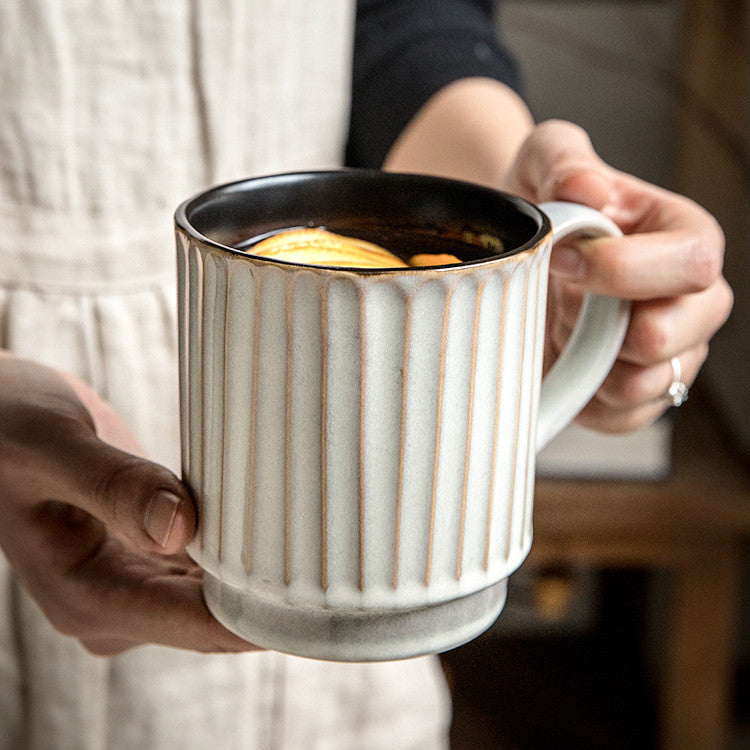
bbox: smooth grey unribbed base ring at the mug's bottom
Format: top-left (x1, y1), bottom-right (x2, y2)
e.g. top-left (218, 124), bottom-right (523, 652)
top-left (203, 572), bottom-right (507, 662)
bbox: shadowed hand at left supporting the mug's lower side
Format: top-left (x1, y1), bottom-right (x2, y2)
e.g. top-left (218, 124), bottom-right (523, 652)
top-left (0, 354), bottom-right (253, 655)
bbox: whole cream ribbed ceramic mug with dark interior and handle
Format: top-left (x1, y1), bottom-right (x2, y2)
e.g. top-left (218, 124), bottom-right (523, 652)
top-left (176, 170), bottom-right (628, 661)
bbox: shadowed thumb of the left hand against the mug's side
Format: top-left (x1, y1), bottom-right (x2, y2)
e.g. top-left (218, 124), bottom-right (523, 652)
top-left (0, 354), bottom-right (195, 554)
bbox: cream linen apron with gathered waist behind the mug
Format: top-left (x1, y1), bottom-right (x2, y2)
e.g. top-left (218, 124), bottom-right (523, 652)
top-left (0, 0), bottom-right (449, 750)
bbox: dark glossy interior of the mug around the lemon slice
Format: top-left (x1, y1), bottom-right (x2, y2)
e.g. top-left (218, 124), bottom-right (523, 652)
top-left (175, 169), bottom-right (550, 272)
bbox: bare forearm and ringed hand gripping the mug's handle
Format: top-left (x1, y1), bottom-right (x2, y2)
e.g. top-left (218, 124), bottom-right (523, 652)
top-left (384, 78), bottom-right (733, 432)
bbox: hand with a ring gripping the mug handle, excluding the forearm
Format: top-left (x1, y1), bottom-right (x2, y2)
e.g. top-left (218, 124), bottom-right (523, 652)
top-left (502, 121), bottom-right (733, 432)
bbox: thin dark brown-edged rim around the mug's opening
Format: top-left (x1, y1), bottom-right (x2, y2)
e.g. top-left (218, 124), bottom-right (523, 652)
top-left (174, 167), bottom-right (552, 276)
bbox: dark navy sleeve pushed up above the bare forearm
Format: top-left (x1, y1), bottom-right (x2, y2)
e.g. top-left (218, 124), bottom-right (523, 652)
top-left (346, 0), bottom-right (520, 167)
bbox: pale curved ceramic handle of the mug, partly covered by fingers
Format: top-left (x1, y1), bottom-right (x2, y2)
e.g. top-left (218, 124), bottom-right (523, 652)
top-left (536, 201), bottom-right (630, 451)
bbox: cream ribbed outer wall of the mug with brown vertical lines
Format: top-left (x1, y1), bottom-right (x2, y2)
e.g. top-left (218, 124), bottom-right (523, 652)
top-left (178, 238), bottom-right (547, 607)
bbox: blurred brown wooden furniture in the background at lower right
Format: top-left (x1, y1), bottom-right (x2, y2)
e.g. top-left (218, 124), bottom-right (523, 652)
top-left (529, 393), bottom-right (750, 750)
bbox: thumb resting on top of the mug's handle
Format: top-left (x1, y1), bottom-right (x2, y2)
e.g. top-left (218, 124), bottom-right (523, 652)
top-left (514, 120), bottom-right (615, 210)
